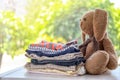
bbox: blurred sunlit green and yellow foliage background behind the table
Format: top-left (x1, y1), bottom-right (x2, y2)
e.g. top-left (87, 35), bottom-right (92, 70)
top-left (0, 0), bottom-right (120, 73)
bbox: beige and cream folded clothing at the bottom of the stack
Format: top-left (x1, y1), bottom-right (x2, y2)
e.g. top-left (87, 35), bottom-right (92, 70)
top-left (25, 63), bottom-right (86, 75)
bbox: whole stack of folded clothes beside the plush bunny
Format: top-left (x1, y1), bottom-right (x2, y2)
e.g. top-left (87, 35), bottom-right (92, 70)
top-left (25, 41), bottom-right (86, 75)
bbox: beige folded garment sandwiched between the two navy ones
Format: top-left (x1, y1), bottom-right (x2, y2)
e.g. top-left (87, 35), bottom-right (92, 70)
top-left (25, 52), bottom-right (83, 60)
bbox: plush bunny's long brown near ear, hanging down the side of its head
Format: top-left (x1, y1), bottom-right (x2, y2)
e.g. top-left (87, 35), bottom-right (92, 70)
top-left (93, 9), bottom-right (107, 41)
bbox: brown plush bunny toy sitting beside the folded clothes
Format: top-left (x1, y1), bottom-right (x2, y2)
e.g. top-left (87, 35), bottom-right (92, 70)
top-left (80, 9), bottom-right (118, 74)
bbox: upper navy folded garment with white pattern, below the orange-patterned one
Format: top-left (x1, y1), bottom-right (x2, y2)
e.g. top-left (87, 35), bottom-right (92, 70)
top-left (26, 45), bottom-right (80, 57)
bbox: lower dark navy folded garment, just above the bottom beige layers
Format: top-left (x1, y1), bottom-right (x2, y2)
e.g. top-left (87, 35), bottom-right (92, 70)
top-left (31, 57), bottom-right (85, 66)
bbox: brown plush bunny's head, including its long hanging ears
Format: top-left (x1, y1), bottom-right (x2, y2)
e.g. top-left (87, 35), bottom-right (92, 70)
top-left (80, 9), bottom-right (107, 41)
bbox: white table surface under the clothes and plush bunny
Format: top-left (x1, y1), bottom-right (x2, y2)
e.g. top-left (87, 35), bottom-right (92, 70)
top-left (0, 67), bottom-right (120, 80)
